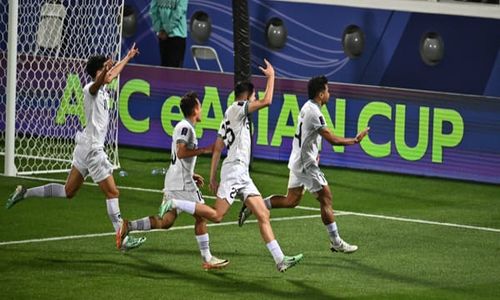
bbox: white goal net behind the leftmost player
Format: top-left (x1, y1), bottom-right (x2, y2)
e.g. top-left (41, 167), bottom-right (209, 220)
top-left (0, 0), bottom-right (123, 175)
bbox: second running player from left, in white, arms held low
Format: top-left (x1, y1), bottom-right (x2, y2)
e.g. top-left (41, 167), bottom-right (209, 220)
top-left (121, 92), bottom-right (229, 270)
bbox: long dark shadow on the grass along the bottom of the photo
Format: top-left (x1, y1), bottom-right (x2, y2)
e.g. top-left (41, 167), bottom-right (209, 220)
top-left (11, 251), bottom-right (336, 300)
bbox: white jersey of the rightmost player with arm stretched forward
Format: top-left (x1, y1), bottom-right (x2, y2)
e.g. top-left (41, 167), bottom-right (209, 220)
top-left (288, 100), bottom-right (326, 173)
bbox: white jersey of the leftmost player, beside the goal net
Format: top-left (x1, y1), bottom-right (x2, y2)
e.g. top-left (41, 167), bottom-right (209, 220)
top-left (83, 82), bottom-right (109, 149)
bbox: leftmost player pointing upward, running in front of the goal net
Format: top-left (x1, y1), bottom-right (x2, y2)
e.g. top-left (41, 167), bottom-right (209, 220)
top-left (5, 43), bottom-right (145, 250)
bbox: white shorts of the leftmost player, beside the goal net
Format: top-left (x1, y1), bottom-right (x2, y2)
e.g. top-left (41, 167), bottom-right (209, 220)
top-left (72, 144), bottom-right (113, 183)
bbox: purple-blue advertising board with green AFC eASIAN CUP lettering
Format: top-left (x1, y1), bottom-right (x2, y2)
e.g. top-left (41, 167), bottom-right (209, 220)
top-left (53, 65), bottom-right (500, 184)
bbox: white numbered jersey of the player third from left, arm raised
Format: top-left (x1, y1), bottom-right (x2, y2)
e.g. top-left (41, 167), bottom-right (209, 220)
top-left (218, 101), bottom-right (251, 168)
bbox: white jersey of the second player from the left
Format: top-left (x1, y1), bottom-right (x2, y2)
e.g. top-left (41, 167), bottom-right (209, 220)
top-left (165, 119), bottom-right (198, 191)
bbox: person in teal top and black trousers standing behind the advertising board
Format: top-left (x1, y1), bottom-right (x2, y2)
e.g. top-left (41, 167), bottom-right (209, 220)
top-left (149, 0), bottom-right (188, 68)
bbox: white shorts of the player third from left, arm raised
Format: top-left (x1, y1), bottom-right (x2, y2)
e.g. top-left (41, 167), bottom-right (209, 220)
top-left (217, 165), bottom-right (260, 205)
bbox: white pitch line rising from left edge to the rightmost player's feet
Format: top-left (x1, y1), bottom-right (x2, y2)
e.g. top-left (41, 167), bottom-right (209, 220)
top-left (0, 214), bottom-right (326, 246)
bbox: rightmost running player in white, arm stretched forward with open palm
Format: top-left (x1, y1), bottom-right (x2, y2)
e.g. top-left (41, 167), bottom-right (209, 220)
top-left (238, 76), bottom-right (370, 253)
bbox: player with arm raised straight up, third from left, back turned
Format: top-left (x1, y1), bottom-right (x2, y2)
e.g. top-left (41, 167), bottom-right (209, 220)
top-left (160, 60), bottom-right (302, 272)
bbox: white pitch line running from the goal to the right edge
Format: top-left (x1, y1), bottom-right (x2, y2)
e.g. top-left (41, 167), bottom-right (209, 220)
top-left (0, 176), bottom-right (500, 237)
